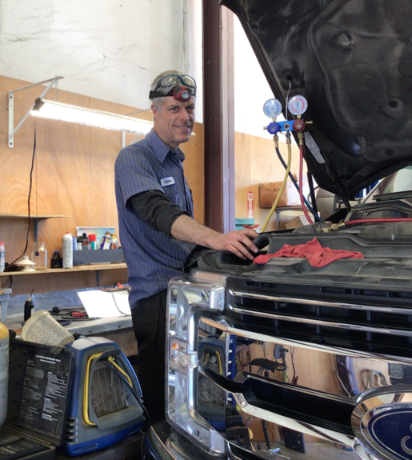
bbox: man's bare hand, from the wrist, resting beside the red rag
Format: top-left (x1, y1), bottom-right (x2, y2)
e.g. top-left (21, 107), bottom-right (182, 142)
top-left (207, 229), bottom-right (258, 260)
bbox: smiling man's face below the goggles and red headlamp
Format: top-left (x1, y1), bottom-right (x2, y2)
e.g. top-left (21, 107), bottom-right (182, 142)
top-left (152, 96), bottom-right (196, 150)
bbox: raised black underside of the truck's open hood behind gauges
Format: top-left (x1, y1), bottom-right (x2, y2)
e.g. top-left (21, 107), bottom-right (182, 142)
top-left (221, 0), bottom-right (412, 199)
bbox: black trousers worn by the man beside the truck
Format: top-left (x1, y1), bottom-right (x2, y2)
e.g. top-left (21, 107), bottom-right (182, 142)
top-left (132, 289), bottom-right (167, 423)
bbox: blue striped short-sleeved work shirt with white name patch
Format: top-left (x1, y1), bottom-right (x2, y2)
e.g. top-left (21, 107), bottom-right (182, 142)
top-left (115, 129), bottom-right (195, 308)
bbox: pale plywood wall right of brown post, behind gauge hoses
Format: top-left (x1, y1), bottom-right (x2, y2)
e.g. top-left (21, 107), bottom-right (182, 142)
top-left (235, 132), bottom-right (306, 231)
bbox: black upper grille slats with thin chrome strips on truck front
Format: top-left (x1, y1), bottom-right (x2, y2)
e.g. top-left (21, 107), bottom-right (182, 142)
top-left (226, 278), bottom-right (412, 357)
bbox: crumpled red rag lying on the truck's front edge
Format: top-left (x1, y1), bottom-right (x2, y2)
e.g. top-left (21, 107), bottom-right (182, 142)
top-left (253, 238), bottom-right (363, 267)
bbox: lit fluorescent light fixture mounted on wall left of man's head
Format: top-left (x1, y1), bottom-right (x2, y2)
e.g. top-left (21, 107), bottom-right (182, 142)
top-left (31, 98), bottom-right (153, 134)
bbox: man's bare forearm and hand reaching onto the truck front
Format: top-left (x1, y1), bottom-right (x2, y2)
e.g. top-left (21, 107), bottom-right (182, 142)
top-left (171, 215), bottom-right (258, 260)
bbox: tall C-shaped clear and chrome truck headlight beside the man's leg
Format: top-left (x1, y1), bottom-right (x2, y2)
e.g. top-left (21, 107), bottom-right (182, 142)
top-left (166, 271), bottom-right (226, 455)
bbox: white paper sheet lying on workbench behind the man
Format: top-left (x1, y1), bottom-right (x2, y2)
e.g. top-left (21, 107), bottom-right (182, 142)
top-left (77, 291), bottom-right (131, 318)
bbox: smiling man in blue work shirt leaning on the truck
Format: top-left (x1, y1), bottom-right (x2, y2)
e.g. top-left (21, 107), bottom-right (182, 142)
top-left (115, 70), bottom-right (257, 423)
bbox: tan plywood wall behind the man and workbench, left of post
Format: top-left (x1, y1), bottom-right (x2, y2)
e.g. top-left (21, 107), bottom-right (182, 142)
top-left (0, 76), bottom-right (204, 293)
